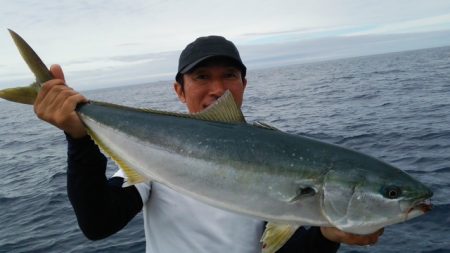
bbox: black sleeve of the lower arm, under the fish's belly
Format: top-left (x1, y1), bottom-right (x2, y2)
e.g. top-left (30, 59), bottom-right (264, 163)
top-left (277, 227), bottom-right (340, 253)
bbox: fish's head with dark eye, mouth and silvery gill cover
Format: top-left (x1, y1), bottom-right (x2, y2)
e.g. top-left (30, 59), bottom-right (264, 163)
top-left (322, 165), bottom-right (433, 234)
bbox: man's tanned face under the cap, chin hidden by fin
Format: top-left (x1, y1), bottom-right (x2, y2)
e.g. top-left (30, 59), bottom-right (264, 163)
top-left (174, 64), bottom-right (247, 113)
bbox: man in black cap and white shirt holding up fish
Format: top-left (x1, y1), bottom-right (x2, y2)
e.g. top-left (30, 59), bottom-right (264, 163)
top-left (34, 36), bottom-right (382, 253)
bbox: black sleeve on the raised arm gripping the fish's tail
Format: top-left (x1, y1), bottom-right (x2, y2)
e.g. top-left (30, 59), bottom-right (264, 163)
top-left (66, 135), bottom-right (143, 240)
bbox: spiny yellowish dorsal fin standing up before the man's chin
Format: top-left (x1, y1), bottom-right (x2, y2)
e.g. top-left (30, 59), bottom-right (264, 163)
top-left (191, 90), bottom-right (245, 123)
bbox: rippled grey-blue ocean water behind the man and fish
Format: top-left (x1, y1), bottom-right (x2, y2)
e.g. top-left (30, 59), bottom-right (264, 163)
top-left (0, 47), bottom-right (450, 253)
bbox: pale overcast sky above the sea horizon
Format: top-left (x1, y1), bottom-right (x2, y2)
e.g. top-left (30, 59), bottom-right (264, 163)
top-left (0, 0), bottom-right (450, 90)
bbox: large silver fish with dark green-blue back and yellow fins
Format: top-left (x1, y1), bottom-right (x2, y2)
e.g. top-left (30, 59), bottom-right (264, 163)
top-left (0, 31), bottom-right (432, 252)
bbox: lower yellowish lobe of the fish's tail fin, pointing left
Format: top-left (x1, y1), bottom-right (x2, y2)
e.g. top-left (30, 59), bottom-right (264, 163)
top-left (0, 83), bottom-right (40, 105)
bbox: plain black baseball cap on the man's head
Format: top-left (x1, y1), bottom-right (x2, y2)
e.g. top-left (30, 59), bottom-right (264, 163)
top-left (175, 35), bottom-right (247, 81)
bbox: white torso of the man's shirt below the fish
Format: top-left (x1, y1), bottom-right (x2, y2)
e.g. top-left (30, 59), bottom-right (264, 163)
top-left (114, 170), bottom-right (264, 253)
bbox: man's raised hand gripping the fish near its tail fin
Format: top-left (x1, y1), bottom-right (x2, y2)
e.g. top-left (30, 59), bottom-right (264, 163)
top-left (34, 65), bottom-right (88, 138)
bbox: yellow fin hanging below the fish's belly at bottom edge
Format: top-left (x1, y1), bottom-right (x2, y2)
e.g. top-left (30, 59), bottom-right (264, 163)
top-left (261, 222), bottom-right (299, 253)
